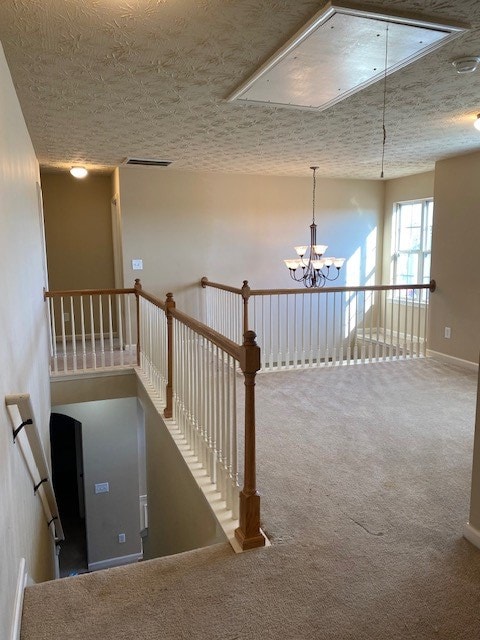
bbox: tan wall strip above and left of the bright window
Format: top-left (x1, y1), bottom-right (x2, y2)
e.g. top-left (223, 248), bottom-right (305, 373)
top-left (382, 171), bottom-right (436, 284)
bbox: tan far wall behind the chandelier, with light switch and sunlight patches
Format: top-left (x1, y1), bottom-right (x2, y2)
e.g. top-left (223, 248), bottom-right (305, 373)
top-left (119, 167), bottom-right (384, 311)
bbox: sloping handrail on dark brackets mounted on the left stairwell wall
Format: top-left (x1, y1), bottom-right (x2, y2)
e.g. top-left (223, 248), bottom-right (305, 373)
top-left (5, 393), bottom-right (65, 542)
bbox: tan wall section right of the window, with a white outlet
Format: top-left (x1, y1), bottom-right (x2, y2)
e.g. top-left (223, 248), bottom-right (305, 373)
top-left (430, 152), bottom-right (480, 363)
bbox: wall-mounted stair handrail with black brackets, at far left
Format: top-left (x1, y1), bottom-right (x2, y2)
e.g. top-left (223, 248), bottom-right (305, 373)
top-left (5, 393), bottom-right (65, 542)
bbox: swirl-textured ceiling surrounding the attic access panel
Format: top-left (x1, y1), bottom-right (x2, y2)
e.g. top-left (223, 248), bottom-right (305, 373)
top-left (0, 0), bottom-right (480, 179)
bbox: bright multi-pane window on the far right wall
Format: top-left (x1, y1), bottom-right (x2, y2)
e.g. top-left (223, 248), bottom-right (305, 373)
top-left (391, 199), bottom-right (433, 284)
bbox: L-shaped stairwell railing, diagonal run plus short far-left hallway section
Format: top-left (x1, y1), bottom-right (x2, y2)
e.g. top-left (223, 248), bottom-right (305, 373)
top-left (45, 280), bottom-right (265, 549)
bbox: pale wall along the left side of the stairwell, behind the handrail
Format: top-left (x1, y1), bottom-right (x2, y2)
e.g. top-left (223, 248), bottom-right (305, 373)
top-left (0, 45), bottom-right (53, 638)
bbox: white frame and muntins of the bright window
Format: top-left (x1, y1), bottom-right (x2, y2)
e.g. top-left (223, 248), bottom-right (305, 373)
top-left (390, 198), bottom-right (433, 299)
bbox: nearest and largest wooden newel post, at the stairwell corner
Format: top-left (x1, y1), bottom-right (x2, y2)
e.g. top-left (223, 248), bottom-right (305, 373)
top-left (235, 331), bottom-right (265, 550)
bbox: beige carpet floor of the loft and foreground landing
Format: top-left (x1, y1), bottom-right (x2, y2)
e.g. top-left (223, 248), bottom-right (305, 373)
top-left (21, 361), bottom-right (480, 640)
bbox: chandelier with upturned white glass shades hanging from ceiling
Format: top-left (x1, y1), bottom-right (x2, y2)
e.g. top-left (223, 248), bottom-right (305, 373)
top-left (284, 167), bottom-right (345, 288)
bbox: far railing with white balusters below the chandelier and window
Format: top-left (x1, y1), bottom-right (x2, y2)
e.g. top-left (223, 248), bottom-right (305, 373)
top-left (201, 278), bottom-right (435, 371)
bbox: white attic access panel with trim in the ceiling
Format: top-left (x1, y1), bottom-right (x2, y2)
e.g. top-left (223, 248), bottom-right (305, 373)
top-left (228, 3), bottom-right (466, 111)
